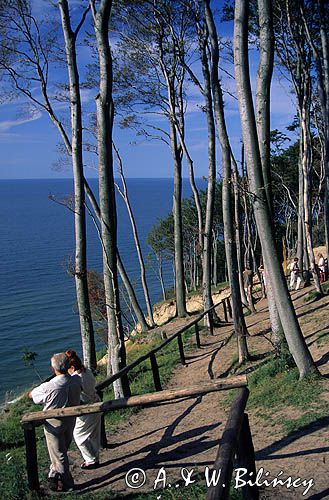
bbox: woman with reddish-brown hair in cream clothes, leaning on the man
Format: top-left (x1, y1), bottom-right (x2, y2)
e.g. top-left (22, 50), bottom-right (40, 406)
top-left (66, 351), bottom-right (101, 470)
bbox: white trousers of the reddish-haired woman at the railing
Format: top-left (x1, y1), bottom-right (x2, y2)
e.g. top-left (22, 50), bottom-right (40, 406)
top-left (73, 413), bottom-right (101, 464)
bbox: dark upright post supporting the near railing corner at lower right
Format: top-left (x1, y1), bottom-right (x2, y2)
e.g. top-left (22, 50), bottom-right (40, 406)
top-left (237, 413), bottom-right (259, 500)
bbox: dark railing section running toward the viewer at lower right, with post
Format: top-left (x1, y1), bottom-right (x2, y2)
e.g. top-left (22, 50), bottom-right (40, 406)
top-left (206, 387), bottom-right (259, 500)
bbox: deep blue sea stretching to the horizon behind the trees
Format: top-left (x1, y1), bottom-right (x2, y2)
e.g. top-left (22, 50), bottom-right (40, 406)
top-left (0, 178), bottom-right (203, 404)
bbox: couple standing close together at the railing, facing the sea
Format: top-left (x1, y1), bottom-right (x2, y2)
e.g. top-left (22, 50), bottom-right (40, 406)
top-left (29, 351), bottom-right (101, 491)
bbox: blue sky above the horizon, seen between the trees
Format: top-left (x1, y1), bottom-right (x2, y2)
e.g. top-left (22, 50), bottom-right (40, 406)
top-left (0, 0), bottom-right (296, 179)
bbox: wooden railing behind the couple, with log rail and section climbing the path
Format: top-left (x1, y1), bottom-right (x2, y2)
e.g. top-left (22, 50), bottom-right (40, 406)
top-left (21, 297), bottom-right (232, 490)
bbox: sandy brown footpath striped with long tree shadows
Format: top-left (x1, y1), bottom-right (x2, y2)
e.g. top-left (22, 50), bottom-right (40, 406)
top-left (71, 290), bottom-right (329, 499)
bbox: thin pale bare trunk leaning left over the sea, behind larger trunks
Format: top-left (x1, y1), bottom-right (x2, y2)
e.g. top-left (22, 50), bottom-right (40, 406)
top-left (113, 144), bottom-right (155, 327)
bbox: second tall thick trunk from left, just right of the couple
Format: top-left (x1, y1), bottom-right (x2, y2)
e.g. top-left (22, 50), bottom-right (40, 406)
top-left (92, 0), bottom-right (130, 398)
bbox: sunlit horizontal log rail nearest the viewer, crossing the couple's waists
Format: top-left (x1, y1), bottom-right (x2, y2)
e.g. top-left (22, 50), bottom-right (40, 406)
top-left (21, 375), bottom-right (247, 426)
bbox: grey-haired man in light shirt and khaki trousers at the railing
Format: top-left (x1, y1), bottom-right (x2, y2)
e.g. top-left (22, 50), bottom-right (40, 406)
top-left (29, 352), bottom-right (81, 491)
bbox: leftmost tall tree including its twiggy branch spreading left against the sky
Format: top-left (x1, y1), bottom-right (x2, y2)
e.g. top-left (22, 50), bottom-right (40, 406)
top-left (0, 0), bottom-right (96, 368)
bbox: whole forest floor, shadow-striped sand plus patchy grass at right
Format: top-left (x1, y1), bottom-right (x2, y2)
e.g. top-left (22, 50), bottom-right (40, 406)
top-left (70, 288), bottom-right (329, 500)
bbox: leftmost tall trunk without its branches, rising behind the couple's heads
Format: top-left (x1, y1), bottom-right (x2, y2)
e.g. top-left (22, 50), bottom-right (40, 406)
top-left (58, 0), bottom-right (97, 369)
